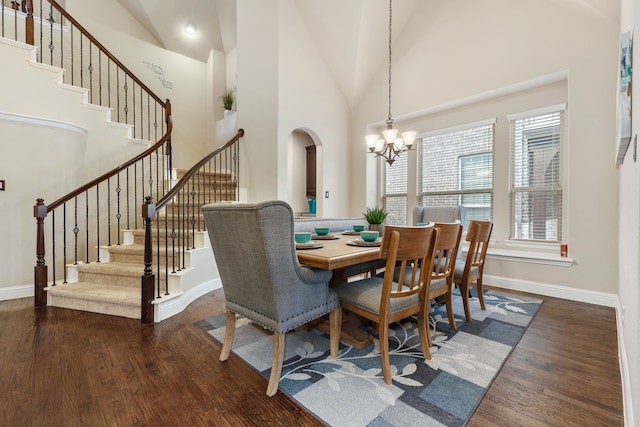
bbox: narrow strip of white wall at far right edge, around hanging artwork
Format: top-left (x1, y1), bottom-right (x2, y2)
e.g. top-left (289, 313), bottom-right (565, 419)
top-left (613, 0), bottom-right (640, 426)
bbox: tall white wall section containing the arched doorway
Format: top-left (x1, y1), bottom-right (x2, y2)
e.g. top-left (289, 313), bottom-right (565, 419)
top-left (278, 0), bottom-right (351, 218)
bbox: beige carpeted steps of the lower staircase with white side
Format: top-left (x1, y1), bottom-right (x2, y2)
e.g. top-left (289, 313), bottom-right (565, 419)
top-left (45, 170), bottom-right (236, 321)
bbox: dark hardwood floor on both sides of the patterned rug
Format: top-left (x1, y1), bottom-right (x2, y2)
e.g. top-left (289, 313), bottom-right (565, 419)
top-left (0, 291), bottom-right (624, 427)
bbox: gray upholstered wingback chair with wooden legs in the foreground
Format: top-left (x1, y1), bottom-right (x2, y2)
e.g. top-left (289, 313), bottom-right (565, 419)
top-left (202, 201), bottom-right (342, 396)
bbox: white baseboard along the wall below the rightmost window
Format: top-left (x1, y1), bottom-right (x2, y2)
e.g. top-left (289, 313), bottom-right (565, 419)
top-left (483, 274), bottom-right (618, 308)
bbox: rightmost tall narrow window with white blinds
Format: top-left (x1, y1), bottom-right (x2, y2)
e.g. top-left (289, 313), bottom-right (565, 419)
top-left (508, 105), bottom-right (564, 242)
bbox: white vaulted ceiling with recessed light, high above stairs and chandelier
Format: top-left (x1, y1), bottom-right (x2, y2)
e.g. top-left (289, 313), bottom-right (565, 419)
top-left (117, 0), bottom-right (620, 106)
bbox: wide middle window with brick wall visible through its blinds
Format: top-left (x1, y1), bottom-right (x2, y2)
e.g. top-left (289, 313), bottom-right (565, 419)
top-left (418, 120), bottom-right (495, 230)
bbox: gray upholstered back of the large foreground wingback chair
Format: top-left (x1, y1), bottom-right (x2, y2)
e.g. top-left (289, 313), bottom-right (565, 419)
top-left (202, 201), bottom-right (328, 328)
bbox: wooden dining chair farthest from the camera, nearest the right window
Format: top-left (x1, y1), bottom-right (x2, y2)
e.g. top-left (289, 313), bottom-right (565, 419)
top-left (453, 220), bottom-right (493, 322)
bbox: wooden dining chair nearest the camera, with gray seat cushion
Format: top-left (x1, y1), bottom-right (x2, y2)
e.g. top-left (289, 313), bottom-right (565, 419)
top-left (334, 225), bottom-right (438, 384)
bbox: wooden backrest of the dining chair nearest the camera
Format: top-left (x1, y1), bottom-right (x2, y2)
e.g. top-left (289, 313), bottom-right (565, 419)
top-left (380, 225), bottom-right (439, 302)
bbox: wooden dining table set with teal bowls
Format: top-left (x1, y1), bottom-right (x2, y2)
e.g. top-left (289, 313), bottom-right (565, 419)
top-left (296, 231), bottom-right (385, 348)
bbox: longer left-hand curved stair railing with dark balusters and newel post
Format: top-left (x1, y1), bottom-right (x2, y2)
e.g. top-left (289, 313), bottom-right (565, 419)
top-left (25, 0), bottom-right (173, 320)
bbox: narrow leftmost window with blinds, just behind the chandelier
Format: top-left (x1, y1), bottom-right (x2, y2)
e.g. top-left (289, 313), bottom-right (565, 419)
top-left (382, 153), bottom-right (408, 225)
